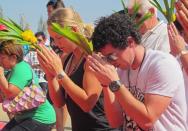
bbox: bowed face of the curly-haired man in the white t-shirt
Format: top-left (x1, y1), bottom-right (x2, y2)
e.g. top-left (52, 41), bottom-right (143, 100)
top-left (100, 44), bottom-right (134, 69)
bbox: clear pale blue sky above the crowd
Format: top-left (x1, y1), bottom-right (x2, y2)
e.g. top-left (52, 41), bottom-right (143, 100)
top-left (0, 0), bottom-right (164, 31)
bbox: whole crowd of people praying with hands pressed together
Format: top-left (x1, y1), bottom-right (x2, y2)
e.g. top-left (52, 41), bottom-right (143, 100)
top-left (0, 0), bottom-right (188, 131)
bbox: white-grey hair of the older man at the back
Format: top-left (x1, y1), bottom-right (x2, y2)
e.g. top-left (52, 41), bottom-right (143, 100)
top-left (128, 0), bottom-right (157, 16)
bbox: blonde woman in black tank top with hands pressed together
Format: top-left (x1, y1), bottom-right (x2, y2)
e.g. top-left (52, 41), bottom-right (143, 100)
top-left (38, 8), bottom-right (119, 131)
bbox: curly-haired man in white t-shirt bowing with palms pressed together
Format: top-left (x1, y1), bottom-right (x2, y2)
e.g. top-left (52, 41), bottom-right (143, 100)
top-left (86, 13), bottom-right (187, 131)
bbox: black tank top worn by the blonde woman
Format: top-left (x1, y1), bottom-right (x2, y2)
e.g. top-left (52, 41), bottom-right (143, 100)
top-left (63, 54), bottom-right (120, 131)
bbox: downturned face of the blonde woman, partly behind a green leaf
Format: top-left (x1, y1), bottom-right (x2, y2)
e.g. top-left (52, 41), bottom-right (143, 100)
top-left (48, 27), bottom-right (77, 53)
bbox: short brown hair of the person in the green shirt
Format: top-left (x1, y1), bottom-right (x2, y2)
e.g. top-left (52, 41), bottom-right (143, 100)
top-left (0, 40), bottom-right (24, 62)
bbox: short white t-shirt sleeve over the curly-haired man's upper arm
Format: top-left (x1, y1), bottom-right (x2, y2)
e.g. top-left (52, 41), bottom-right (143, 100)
top-left (146, 58), bottom-right (183, 97)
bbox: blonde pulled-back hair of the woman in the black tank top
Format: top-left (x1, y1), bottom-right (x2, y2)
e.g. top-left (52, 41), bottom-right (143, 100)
top-left (48, 8), bottom-right (94, 38)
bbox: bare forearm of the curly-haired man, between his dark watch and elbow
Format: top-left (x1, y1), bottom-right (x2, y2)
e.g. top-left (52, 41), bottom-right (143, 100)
top-left (115, 85), bottom-right (157, 129)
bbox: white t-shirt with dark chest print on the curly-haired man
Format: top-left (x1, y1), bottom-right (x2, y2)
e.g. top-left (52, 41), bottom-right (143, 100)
top-left (118, 50), bottom-right (188, 131)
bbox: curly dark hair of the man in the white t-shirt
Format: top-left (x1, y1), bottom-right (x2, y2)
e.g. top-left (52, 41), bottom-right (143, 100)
top-left (92, 13), bottom-right (141, 51)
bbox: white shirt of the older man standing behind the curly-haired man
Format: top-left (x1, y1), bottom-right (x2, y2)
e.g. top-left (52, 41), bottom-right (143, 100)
top-left (141, 21), bottom-right (170, 53)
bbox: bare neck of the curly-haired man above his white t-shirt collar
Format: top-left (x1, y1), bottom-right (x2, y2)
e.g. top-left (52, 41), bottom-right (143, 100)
top-left (131, 45), bottom-right (145, 70)
